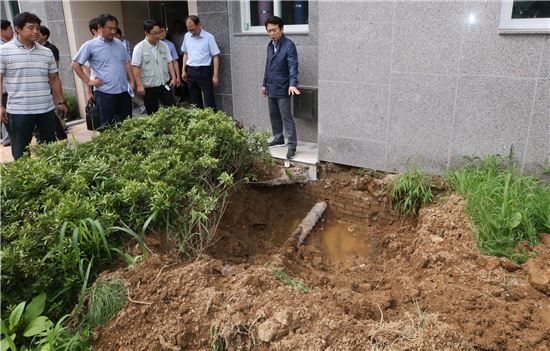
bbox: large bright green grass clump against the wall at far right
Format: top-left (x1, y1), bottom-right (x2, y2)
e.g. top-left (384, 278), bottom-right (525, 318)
top-left (447, 156), bottom-right (550, 263)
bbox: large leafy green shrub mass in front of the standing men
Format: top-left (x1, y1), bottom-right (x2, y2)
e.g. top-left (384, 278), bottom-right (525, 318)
top-left (0, 107), bottom-right (269, 318)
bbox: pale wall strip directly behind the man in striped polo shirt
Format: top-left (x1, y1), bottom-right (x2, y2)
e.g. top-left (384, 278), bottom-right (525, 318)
top-left (19, 0), bottom-right (76, 96)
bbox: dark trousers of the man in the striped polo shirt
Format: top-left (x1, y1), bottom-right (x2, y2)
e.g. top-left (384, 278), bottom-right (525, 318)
top-left (8, 110), bottom-right (57, 160)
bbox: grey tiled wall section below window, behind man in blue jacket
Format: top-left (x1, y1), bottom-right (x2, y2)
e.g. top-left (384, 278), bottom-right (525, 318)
top-left (224, 1), bottom-right (321, 142)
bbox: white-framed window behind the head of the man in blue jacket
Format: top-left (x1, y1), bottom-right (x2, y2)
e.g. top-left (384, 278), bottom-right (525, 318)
top-left (241, 0), bottom-right (309, 33)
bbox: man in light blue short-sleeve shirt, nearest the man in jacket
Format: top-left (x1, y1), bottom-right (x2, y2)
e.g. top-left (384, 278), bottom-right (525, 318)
top-left (181, 16), bottom-right (220, 111)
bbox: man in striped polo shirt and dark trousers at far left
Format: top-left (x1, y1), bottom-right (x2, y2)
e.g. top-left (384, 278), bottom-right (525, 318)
top-left (0, 12), bottom-right (67, 160)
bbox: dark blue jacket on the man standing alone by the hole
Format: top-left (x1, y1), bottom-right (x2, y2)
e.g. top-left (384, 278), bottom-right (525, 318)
top-left (263, 35), bottom-right (298, 98)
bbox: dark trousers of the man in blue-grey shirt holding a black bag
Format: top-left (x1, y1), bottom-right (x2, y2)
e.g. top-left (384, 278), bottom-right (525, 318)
top-left (94, 90), bottom-right (132, 128)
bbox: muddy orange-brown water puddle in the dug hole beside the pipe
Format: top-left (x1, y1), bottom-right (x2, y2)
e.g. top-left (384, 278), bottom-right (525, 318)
top-left (319, 220), bottom-right (370, 266)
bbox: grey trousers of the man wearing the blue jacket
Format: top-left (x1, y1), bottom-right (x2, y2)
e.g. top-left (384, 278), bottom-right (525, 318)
top-left (267, 96), bottom-right (298, 150)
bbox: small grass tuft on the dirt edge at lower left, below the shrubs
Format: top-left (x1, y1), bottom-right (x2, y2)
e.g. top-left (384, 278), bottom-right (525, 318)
top-left (86, 280), bottom-right (126, 328)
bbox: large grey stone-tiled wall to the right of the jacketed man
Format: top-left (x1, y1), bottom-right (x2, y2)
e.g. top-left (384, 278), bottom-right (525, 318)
top-left (318, 1), bottom-right (550, 173)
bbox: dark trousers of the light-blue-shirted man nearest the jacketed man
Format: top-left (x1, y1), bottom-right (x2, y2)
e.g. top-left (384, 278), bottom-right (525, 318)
top-left (185, 66), bottom-right (216, 111)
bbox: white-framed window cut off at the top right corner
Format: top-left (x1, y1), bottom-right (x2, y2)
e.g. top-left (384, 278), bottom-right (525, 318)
top-left (499, 0), bottom-right (550, 33)
